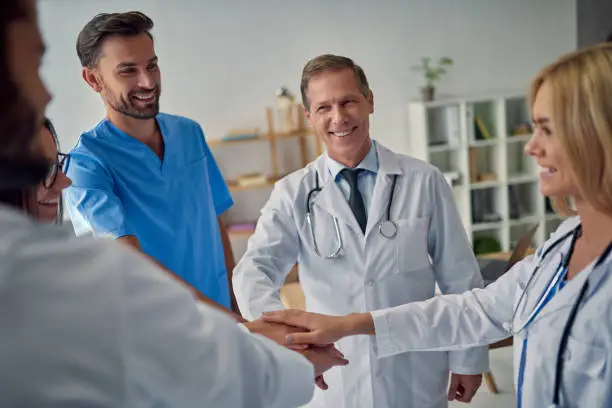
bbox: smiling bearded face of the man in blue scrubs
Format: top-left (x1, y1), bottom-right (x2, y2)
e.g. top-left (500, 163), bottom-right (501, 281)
top-left (83, 33), bottom-right (161, 119)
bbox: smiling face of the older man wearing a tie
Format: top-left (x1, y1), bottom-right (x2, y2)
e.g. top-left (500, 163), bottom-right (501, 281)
top-left (306, 69), bottom-right (374, 167)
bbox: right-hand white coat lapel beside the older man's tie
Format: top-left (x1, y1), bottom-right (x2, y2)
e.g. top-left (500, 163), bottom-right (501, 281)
top-left (365, 143), bottom-right (402, 236)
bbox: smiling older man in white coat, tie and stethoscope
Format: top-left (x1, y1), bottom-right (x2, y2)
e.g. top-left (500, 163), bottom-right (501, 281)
top-left (233, 55), bottom-right (488, 408)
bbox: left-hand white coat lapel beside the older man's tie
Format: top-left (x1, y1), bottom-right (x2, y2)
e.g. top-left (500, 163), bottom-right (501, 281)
top-left (313, 155), bottom-right (361, 234)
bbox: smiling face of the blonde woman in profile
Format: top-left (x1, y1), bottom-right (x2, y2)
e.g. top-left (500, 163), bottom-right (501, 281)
top-left (525, 82), bottom-right (578, 197)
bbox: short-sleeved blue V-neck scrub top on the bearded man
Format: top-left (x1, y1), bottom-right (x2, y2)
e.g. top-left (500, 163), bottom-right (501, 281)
top-left (65, 113), bottom-right (233, 308)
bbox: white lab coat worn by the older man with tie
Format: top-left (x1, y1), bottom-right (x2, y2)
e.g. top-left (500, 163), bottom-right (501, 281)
top-left (233, 144), bottom-right (488, 408)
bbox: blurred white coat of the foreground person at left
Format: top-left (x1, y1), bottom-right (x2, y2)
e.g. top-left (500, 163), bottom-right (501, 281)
top-left (0, 206), bottom-right (314, 408)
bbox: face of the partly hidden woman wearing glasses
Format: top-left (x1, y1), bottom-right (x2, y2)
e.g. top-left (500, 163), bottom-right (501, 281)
top-left (35, 118), bottom-right (72, 224)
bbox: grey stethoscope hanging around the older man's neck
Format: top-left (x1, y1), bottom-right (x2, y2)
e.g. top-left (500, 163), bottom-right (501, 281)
top-left (306, 170), bottom-right (397, 259)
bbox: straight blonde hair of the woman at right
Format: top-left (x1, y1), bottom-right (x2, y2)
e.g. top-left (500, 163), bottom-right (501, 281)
top-left (529, 43), bottom-right (612, 216)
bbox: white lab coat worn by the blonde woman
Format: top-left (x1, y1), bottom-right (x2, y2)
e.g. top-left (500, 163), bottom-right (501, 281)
top-left (373, 217), bottom-right (612, 408)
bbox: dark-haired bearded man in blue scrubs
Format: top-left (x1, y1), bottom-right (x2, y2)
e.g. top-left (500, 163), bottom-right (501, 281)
top-left (66, 12), bottom-right (238, 313)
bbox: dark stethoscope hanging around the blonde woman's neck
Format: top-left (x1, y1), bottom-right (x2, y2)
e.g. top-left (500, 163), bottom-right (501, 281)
top-left (508, 225), bottom-right (612, 408)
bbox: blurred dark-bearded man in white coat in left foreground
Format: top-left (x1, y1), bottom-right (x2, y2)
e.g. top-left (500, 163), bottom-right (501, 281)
top-left (0, 0), bottom-right (347, 408)
